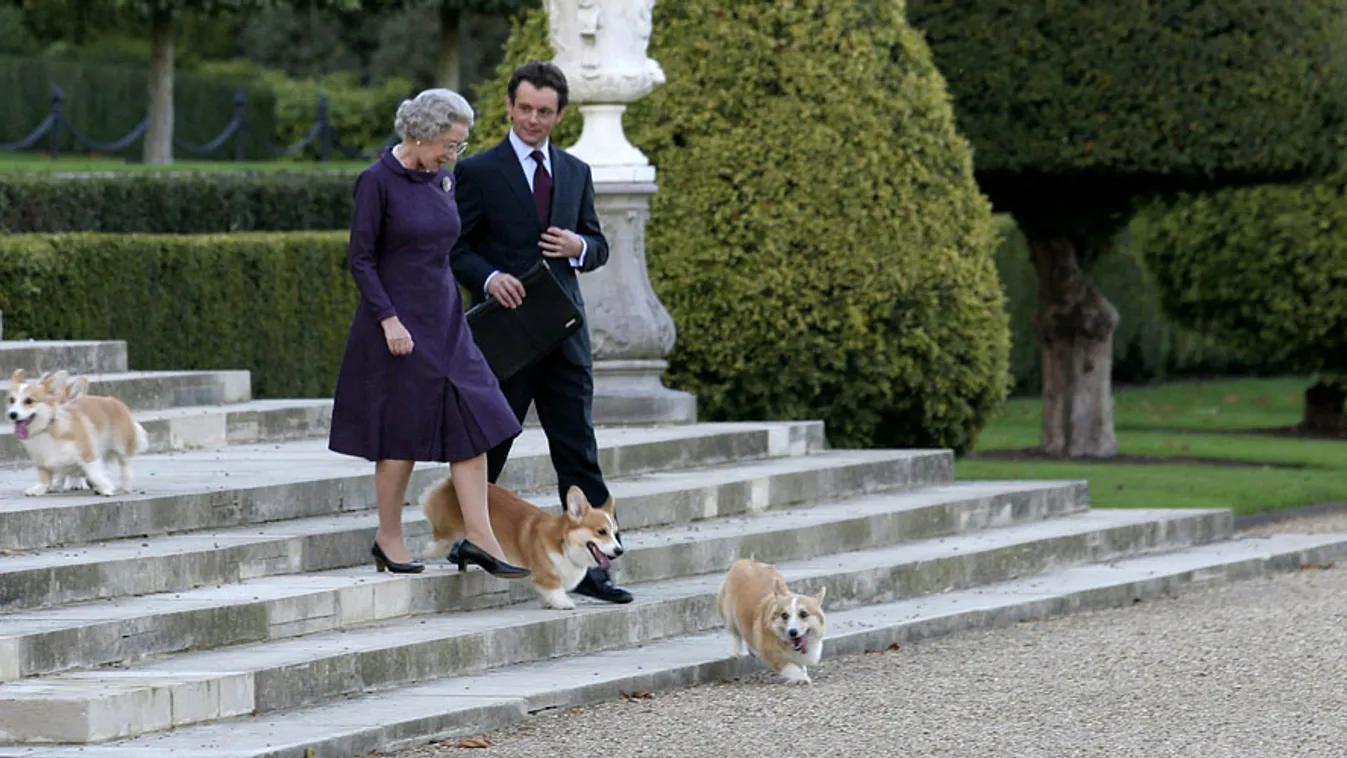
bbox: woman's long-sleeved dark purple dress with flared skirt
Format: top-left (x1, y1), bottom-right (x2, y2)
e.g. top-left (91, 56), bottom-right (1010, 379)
top-left (327, 149), bottom-right (521, 462)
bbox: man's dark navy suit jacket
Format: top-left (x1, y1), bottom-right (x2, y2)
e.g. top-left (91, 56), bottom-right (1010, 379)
top-left (449, 136), bottom-right (607, 366)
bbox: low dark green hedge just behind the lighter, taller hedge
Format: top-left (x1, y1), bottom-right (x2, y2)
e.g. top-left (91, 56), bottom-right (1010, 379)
top-left (0, 170), bottom-right (358, 234)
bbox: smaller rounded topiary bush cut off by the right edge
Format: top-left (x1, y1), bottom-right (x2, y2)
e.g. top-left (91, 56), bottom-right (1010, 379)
top-left (1133, 172), bottom-right (1347, 431)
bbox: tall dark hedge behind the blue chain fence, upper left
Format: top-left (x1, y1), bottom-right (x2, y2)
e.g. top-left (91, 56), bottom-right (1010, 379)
top-left (0, 57), bottom-right (276, 160)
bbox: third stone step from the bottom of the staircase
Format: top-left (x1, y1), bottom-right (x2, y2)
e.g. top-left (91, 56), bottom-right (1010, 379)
top-left (0, 479), bottom-right (1086, 681)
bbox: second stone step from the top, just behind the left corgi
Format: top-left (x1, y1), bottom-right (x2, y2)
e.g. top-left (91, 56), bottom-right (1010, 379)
top-left (0, 372), bottom-right (252, 412)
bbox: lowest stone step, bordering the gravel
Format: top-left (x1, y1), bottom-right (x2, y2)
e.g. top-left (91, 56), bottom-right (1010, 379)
top-left (23, 535), bottom-right (1347, 758)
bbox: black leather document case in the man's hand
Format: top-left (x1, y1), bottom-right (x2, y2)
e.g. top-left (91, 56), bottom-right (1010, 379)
top-left (467, 261), bottom-right (585, 381)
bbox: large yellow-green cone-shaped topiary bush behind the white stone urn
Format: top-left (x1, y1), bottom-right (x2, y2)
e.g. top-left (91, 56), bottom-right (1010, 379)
top-left (471, 0), bottom-right (1010, 451)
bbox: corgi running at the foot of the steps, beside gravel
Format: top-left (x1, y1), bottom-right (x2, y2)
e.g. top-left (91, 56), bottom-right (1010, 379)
top-left (717, 557), bottom-right (828, 684)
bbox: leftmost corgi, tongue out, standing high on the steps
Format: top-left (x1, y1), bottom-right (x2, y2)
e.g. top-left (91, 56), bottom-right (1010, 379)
top-left (8, 369), bottom-right (150, 497)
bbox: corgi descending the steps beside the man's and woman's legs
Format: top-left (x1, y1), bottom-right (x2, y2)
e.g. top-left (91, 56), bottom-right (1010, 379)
top-left (420, 478), bottom-right (625, 610)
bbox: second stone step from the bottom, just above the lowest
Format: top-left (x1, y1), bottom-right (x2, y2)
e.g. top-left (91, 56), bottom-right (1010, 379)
top-left (0, 509), bottom-right (1231, 743)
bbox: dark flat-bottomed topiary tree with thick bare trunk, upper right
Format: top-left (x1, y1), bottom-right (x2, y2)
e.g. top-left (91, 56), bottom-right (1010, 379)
top-left (909, 0), bottom-right (1347, 456)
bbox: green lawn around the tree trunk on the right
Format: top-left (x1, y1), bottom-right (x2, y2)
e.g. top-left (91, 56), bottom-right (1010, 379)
top-left (956, 380), bottom-right (1347, 516)
